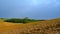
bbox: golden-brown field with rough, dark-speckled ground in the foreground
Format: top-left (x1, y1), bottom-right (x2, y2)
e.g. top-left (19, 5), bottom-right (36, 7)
top-left (0, 18), bottom-right (60, 34)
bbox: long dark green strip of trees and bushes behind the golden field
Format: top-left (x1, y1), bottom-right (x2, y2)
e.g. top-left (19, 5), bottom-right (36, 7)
top-left (4, 17), bottom-right (43, 23)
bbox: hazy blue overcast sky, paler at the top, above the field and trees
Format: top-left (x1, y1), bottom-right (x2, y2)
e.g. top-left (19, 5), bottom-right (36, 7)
top-left (0, 0), bottom-right (60, 19)
